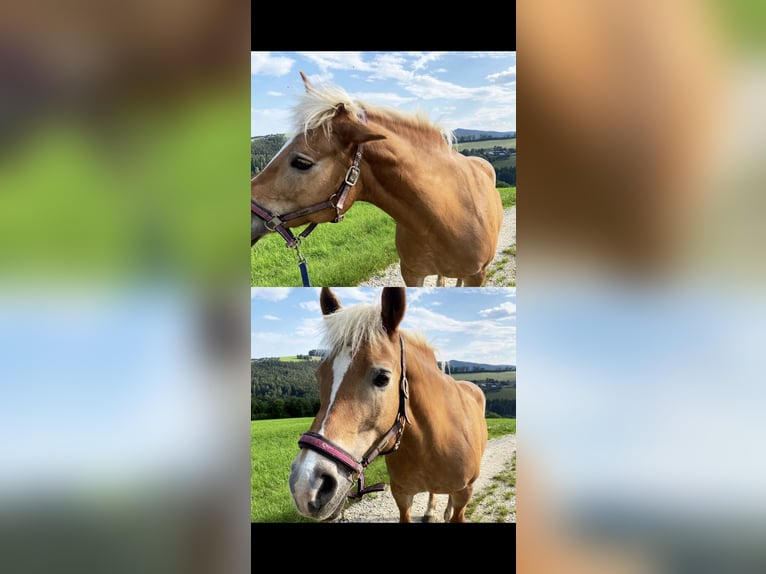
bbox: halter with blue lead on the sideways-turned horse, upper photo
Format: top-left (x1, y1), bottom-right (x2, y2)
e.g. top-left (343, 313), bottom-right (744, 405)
top-left (250, 111), bottom-right (367, 287)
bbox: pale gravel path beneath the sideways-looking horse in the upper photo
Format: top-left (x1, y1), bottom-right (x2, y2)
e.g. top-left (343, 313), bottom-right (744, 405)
top-left (359, 205), bottom-right (516, 287)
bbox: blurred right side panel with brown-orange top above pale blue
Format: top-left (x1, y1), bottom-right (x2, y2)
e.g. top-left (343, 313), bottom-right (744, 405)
top-left (516, 0), bottom-right (766, 574)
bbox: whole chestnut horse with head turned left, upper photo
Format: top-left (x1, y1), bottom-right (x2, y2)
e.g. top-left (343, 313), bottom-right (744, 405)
top-left (250, 72), bottom-right (503, 287)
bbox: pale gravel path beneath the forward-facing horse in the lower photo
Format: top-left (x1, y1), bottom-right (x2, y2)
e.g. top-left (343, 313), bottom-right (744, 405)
top-left (336, 434), bottom-right (516, 522)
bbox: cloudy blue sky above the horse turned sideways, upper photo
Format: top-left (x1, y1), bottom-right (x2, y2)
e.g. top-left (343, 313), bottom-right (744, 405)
top-left (250, 51), bottom-right (516, 136)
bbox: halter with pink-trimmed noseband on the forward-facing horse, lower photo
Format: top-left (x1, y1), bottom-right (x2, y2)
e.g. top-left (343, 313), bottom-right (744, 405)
top-left (298, 333), bottom-right (412, 498)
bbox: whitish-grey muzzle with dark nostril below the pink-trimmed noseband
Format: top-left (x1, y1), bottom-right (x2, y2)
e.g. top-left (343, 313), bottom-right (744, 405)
top-left (289, 451), bottom-right (353, 521)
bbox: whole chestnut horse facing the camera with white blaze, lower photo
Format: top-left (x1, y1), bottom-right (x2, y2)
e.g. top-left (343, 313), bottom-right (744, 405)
top-left (288, 287), bottom-right (487, 523)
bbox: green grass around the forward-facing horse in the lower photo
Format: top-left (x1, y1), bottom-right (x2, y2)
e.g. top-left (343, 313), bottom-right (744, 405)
top-left (250, 417), bottom-right (516, 522)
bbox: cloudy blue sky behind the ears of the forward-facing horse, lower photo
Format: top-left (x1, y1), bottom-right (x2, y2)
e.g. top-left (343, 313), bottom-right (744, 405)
top-left (250, 287), bottom-right (516, 364)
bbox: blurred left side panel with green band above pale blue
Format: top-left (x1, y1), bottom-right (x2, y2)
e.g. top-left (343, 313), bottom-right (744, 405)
top-left (0, 0), bottom-right (250, 573)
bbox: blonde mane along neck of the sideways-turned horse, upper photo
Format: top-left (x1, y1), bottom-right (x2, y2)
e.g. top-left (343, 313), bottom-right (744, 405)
top-left (292, 80), bottom-right (457, 146)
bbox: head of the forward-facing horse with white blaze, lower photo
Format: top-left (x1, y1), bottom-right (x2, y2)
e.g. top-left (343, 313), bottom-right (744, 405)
top-left (289, 287), bottom-right (407, 520)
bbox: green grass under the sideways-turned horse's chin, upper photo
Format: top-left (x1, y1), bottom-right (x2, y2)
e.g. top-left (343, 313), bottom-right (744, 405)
top-left (250, 187), bottom-right (516, 287)
